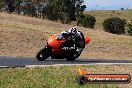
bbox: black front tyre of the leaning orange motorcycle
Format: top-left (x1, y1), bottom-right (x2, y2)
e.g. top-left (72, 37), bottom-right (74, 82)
top-left (36, 47), bottom-right (50, 61)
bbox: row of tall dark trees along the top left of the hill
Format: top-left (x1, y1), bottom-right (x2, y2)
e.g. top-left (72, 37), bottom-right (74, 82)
top-left (0, 0), bottom-right (86, 23)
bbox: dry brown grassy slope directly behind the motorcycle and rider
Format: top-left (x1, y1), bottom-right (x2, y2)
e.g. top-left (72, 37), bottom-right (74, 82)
top-left (0, 11), bottom-right (132, 59)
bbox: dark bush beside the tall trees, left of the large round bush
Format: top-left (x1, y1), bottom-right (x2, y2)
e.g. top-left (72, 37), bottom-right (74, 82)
top-left (81, 14), bottom-right (96, 29)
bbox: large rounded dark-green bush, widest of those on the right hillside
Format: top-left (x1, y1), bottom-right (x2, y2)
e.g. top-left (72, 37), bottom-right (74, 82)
top-left (103, 17), bottom-right (126, 34)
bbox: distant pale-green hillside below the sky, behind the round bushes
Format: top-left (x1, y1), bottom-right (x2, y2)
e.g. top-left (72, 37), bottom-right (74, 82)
top-left (84, 9), bottom-right (132, 29)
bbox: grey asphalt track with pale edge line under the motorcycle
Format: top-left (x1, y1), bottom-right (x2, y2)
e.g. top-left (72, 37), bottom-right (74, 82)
top-left (0, 56), bottom-right (132, 67)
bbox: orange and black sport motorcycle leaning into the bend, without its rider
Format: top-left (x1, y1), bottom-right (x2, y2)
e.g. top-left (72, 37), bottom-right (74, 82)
top-left (36, 34), bottom-right (90, 61)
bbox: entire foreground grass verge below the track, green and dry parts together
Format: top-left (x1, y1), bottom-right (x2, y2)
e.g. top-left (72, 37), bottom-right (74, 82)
top-left (0, 65), bottom-right (132, 88)
